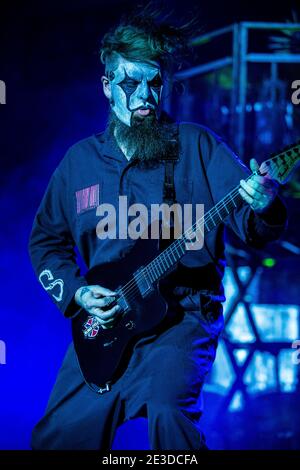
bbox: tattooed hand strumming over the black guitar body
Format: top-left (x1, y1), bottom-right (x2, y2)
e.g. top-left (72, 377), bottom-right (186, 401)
top-left (75, 286), bottom-right (120, 329)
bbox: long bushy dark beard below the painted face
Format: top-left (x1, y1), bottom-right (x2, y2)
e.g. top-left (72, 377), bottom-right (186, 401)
top-left (108, 111), bottom-right (179, 166)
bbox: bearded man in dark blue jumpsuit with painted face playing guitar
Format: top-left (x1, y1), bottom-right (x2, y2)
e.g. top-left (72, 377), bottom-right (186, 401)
top-left (29, 12), bottom-right (286, 450)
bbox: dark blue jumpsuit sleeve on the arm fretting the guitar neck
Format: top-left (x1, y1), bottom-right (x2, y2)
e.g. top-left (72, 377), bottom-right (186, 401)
top-left (200, 126), bottom-right (287, 248)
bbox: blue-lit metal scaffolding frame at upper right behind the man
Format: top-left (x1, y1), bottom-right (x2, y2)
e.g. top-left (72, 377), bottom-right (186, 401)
top-left (165, 22), bottom-right (300, 158)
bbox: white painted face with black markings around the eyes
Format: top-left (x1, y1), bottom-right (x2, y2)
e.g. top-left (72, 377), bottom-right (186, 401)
top-left (108, 56), bottom-right (163, 126)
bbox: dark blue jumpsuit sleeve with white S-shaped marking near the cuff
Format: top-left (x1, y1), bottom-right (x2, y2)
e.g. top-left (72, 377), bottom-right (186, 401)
top-left (29, 169), bottom-right (87, 317)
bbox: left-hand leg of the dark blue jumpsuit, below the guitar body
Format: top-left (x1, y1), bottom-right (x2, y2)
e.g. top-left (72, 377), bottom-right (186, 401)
top-left (31, 344), bottom-right (121, 450)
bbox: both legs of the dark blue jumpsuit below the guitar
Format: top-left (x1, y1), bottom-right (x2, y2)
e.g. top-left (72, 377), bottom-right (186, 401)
top-left (32, 300), bottom-right (221, 450)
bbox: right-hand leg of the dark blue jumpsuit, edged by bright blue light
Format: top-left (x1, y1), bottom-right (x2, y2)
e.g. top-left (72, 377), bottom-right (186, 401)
top-left (120, 312), bottom-right (223, 450)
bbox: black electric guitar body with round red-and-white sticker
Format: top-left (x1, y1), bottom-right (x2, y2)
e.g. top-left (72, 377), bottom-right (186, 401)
top-left (72, 239), bottom-right (166, 393)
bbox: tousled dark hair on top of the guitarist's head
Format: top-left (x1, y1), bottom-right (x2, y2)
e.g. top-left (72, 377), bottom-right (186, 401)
top-left (100, 5), bottom-right (198, 72)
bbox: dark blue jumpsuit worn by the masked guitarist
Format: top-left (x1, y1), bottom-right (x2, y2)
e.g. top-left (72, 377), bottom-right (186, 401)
top-left (29, 122), bottom-right (286, 450)
